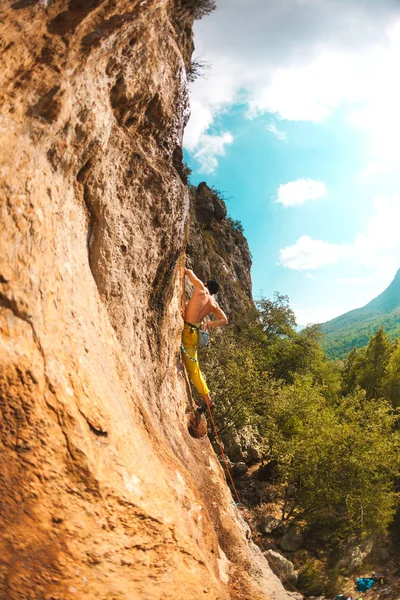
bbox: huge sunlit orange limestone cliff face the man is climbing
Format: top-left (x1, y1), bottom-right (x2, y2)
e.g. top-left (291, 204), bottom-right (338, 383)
top-left (0, 0), bottom-right (294, 600)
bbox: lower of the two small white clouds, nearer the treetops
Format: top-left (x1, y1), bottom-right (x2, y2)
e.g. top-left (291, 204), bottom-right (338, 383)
top-left (280, 235), bottom-right (351, 271)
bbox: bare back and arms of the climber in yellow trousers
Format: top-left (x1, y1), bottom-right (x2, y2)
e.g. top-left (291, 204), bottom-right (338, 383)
top-left (185, 269), bottom-right (228, 328)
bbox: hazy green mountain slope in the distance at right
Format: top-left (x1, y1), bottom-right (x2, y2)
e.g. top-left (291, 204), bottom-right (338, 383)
top-left (322, 269), bottom-right (400, 358)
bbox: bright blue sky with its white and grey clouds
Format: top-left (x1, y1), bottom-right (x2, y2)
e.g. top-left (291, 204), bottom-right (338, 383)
top-left (184, 0), bottom-right (400, 325)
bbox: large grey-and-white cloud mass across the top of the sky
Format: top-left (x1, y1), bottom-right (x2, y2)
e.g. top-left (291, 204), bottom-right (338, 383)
top-left (185, 0), bottom-right (400, 172)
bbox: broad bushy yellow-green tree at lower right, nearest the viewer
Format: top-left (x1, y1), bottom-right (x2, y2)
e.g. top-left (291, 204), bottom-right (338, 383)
top-left (265, 376), bottom-right (400, 539)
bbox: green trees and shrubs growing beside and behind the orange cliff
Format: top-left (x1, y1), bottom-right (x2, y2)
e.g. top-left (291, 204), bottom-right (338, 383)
top-left (189, 184), bottom-right (400, 597)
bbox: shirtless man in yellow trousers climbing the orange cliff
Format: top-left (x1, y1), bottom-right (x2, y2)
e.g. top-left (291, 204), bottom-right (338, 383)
top-left (182, 269), bottom-right (228, 413)
